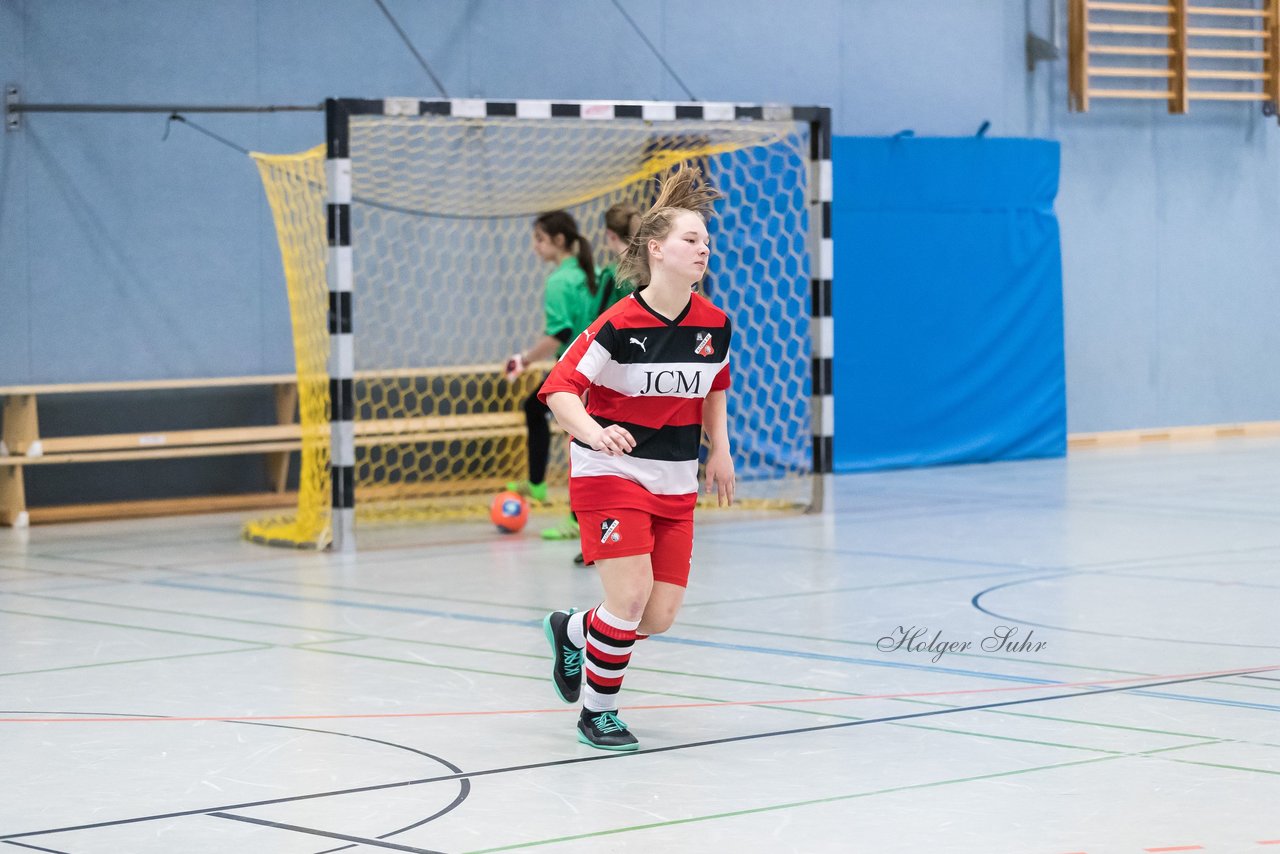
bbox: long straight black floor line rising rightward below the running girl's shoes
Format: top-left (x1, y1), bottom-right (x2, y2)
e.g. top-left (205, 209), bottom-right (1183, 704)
top-left (0, 665), bottom-right (1280, 840)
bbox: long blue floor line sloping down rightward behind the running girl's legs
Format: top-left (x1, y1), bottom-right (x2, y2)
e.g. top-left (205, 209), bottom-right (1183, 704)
top-left (142, 573), bottom-right (1280, 712)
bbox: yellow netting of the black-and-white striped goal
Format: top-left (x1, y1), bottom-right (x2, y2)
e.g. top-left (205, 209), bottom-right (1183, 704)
top-left (248, 117), bottom-right (812, 545)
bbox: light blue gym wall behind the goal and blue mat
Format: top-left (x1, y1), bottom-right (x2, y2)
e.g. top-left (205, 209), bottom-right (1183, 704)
top-left (0, 0), bottom-right (1280, 431)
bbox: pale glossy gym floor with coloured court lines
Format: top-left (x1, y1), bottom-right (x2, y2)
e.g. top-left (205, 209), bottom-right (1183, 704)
top-left (0, 438), bottom-right (1280, 854)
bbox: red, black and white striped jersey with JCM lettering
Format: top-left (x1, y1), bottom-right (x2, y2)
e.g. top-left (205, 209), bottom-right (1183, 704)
top-left (538, 293), bottom-right (733, 519)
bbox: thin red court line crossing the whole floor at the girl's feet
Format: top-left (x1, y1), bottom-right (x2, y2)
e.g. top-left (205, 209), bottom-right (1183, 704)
top-left (0, 665), bottom-right (1280, 727)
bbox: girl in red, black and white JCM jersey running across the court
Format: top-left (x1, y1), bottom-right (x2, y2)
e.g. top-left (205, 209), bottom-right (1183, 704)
top-left (539, 166), bottom-right (733, 750)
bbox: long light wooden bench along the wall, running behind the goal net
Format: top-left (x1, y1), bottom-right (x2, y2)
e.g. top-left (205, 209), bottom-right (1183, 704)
top-left (0, 365), bottom-right (525, 526)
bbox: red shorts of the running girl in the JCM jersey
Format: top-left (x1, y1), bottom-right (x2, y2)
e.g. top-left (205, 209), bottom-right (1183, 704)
top-left (577, 508), bottom-right (694, 588)
